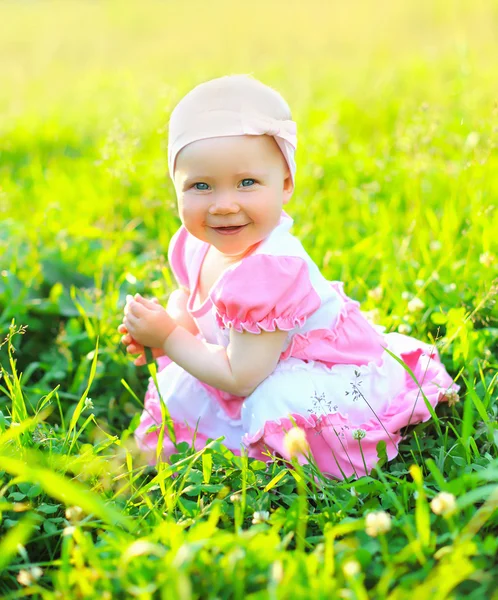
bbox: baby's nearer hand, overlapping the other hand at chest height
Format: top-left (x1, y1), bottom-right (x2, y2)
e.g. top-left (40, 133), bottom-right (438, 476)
top-left (123, 294), bottom-right (177, 349)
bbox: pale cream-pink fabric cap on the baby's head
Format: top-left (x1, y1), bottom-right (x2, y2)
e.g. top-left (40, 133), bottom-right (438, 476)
top-left (168, 75), bottom-right (297, 188)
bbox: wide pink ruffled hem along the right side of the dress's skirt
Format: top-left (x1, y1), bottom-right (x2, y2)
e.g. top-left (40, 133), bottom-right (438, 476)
top-left (242, 348), bottom-right (460, 479)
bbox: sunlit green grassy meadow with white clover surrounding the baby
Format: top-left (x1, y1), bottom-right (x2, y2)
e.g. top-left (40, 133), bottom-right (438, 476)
top-left (0, 0), bottom-right (498, 600)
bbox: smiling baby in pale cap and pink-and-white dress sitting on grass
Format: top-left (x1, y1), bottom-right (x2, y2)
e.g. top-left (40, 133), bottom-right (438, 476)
top-left (119, 75), bottom-right (459, 478)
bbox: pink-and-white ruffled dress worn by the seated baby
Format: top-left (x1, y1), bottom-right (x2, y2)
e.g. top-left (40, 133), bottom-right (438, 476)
top-left (135, 213), bottom-right (459, 478)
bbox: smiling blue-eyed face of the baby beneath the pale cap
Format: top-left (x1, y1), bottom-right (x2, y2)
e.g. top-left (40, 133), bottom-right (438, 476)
top-left (175, 135), bottom-right (294, 258)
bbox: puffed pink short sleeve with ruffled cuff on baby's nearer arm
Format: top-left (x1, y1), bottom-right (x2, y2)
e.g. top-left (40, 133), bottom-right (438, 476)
top-left (210, 254), bottom-right (320, 333)
